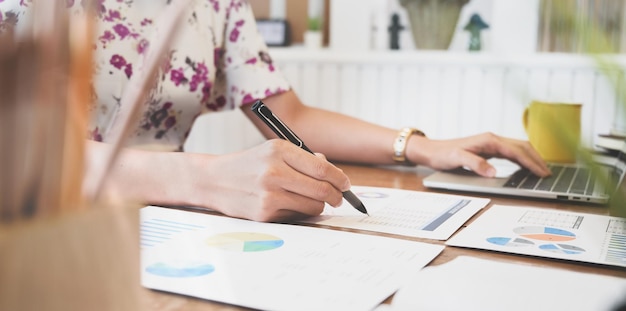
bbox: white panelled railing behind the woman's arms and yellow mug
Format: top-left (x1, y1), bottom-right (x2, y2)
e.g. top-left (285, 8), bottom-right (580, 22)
top-left (186, 48), bottom-right (626, 153)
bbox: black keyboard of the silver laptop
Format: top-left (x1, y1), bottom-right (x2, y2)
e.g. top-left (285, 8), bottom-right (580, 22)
top-left (504, 164), bottom-right (595, 195)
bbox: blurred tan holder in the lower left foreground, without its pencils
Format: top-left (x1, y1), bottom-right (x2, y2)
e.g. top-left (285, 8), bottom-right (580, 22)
top-left (0, 206), bottom-right (142, 311)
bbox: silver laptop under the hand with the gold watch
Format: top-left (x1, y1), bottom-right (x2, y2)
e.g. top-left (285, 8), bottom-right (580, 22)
top-left (423, 143), bottom-right (626, 204)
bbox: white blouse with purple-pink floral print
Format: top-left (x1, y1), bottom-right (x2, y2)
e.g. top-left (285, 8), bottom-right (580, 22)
top-left (0, 0), bottom-right (290, 150)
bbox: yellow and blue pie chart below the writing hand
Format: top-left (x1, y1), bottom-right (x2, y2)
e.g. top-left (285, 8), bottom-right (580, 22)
top-left (205, 232), bottom-right (285, 252)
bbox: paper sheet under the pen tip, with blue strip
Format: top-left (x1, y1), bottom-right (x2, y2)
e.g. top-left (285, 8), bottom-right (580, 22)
top-left (302, 186), bottom-right (489, 240)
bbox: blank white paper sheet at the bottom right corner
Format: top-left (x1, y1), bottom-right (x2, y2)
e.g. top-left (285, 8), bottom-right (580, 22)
top-left (391, 256), bottom-right (626, 311)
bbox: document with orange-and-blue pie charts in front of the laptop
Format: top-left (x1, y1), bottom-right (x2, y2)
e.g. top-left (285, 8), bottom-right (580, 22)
top-left (446, 205), bottom-right (626, 267)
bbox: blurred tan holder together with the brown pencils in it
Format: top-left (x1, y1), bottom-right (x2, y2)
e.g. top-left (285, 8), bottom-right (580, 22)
top-left (0, 0), bottom-right (141, 310)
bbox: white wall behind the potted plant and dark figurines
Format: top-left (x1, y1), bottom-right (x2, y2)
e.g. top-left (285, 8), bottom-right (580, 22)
top-left (330, 0), bottom-right (539, 54)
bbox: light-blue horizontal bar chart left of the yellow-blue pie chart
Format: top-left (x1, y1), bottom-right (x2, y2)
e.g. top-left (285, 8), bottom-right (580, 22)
top-left (140, 218), bottom-right (206, 248)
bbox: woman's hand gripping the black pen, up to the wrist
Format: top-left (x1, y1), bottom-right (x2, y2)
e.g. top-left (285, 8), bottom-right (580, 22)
top-left (187, 139), bottom-right (350, 221)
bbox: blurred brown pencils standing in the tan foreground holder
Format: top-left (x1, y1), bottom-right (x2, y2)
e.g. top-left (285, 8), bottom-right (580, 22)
top-left (0, 1), bottom-right (93, 222)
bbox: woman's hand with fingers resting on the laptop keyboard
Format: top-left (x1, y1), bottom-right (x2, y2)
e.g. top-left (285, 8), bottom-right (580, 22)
top-left (407, 133), bottom-right (550, 177)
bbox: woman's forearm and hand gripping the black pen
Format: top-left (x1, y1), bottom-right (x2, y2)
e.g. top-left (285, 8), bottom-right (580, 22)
top-left (86, 140), bottom-right (350, 221)
